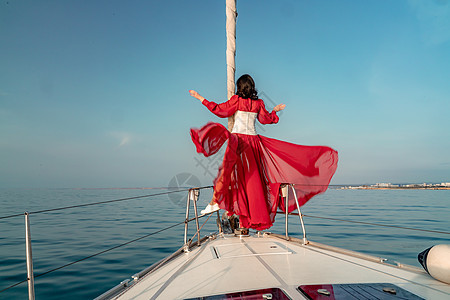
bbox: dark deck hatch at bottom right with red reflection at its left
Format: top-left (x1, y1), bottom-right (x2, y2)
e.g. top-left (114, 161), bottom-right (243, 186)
top-left (298, 283), bottom-right (423, 300)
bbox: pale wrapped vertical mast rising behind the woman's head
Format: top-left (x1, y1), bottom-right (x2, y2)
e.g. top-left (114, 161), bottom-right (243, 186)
top-left (226, 0), bottom-right (237, 131)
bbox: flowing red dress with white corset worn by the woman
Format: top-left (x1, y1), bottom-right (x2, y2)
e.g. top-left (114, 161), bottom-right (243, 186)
top-left (191, 95), bottom-right (338, 230)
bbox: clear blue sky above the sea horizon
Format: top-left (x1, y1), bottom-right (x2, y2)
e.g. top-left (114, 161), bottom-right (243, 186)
top-left (0, 0), bottom-right (450, 187)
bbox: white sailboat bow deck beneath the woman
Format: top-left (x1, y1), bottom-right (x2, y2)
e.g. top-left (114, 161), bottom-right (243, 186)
top-left (110, 234), bottom-right (450, 299)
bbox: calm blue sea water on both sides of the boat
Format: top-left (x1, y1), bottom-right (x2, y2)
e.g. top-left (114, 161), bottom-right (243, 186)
top-left (0, 189), bottom-right (450, 300)
